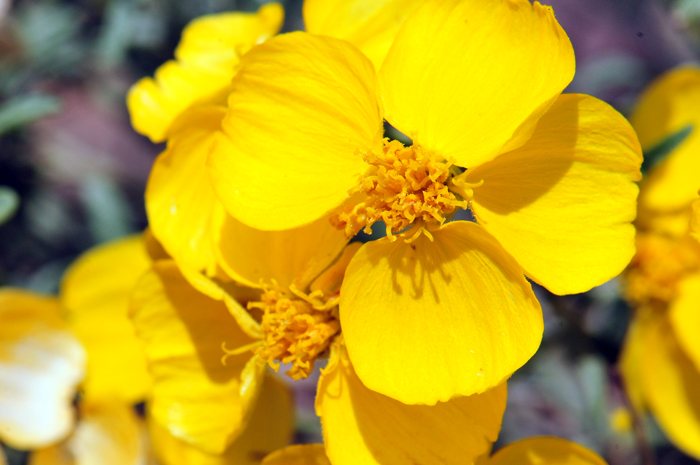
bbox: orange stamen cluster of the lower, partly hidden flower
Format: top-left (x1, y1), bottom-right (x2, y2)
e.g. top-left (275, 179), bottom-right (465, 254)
top-left (248, 283), bottom-right (340, 381)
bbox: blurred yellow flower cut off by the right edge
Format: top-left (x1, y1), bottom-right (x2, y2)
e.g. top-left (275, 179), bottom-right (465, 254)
top-left (620, 68), bottom-right (700, 458)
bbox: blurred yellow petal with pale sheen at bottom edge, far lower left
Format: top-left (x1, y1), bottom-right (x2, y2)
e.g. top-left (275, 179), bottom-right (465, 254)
top-left (29, 401), bottom-right (147, 465)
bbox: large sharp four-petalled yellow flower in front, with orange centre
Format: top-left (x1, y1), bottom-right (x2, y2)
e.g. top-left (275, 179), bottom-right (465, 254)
top-left (209, 0), bottom-right (641, 404)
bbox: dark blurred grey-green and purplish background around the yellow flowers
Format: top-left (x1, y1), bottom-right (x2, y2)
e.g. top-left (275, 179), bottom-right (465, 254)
top-left (0, 0), bottom-right (700, 465)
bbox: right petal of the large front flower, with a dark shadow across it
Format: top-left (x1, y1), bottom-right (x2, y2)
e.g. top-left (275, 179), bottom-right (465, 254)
top-left (467, 94), bottom-right (642, 294)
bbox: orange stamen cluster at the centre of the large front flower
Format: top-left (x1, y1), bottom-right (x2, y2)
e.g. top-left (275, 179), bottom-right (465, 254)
top-left (331, 139), bottom-right (468, 238)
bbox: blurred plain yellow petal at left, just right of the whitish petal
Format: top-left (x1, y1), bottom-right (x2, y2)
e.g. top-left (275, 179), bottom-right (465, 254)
top-left (61, 235), bottom-right (151, 403)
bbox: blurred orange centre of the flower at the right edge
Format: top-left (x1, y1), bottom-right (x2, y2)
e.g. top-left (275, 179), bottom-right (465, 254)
top-left (625, 234), bottom-right (700, 305)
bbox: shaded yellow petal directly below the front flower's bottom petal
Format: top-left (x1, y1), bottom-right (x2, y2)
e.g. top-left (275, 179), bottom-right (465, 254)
top-left (316, 340), bottom-right (506, 465)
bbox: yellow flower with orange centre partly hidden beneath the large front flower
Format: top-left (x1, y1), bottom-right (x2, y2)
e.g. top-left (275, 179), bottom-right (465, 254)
top-left (133, 229), bottom-right (506, 465)
